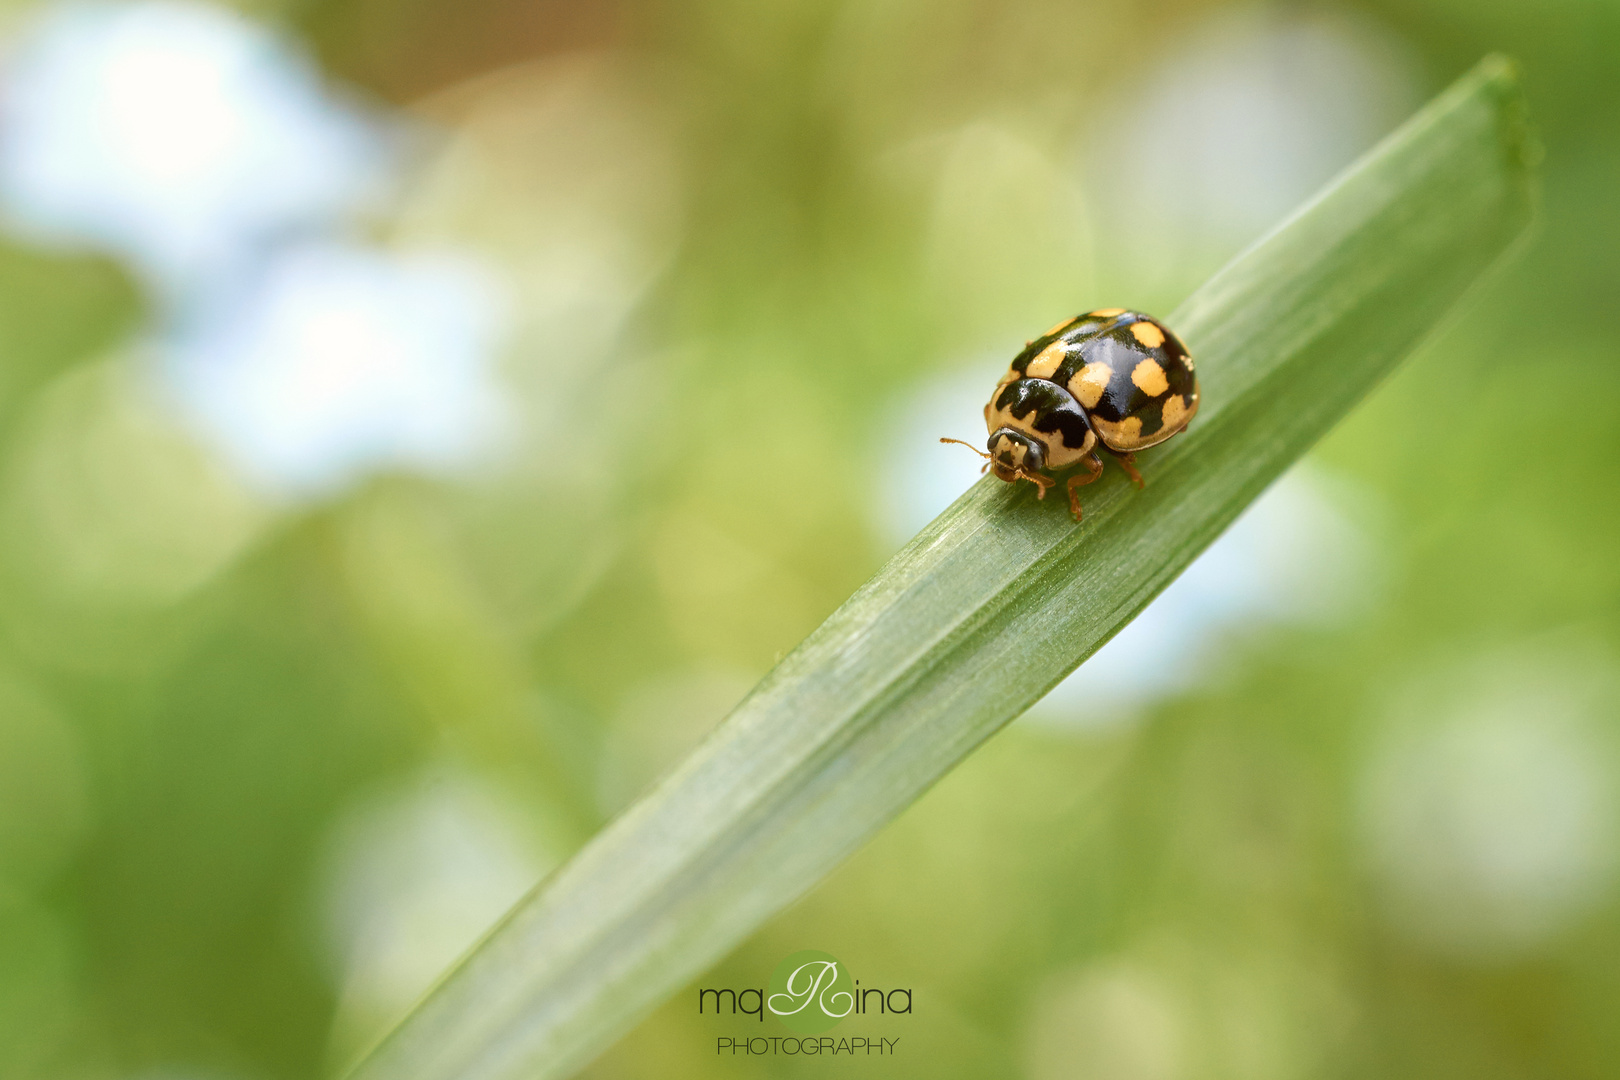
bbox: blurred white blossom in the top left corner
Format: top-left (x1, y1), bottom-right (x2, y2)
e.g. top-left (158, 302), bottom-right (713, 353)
top-left (0, 0), bottom-right (392, 295)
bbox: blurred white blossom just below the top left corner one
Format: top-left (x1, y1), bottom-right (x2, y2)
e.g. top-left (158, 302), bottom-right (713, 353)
top-left (168, 243), bottom-right (507, 497)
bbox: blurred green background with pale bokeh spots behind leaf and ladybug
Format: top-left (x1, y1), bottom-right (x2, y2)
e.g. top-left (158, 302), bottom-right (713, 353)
top-left (0, 0), bottom-right (1620, 1080)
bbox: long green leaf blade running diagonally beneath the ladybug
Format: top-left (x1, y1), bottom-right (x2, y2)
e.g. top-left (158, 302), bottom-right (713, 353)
top-left (341, 58), bottom-right (1534, 1080)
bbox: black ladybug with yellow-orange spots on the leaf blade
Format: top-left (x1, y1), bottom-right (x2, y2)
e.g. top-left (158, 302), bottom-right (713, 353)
top-left (940, 308), bottom-right (1199, 521)
